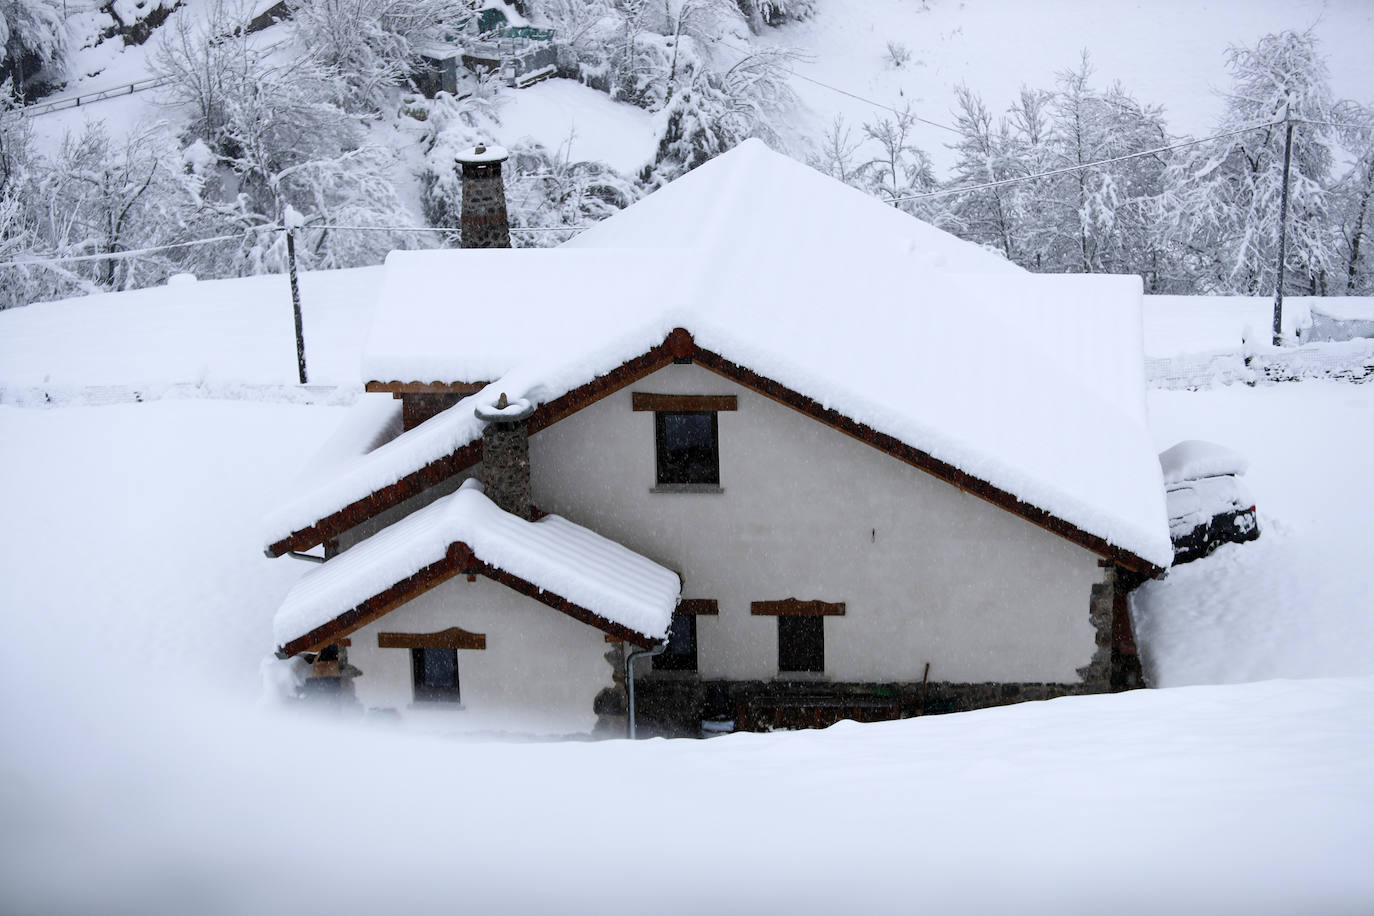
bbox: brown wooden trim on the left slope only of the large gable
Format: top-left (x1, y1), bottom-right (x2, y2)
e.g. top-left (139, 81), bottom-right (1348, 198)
top-left (267, 328), bottom-right (691, 556)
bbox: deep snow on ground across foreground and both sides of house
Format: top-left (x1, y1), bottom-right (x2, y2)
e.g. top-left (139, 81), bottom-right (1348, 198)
top-left (0, 382), bottom-right (1374, 913)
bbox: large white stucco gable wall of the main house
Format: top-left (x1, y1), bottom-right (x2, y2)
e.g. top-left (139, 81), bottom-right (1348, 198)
top-left (530, 365), bottom-right (1101, 683)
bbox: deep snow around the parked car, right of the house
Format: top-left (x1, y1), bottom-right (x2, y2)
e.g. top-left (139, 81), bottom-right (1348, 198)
top-left (1135, 380), bottom-right (1374, 687)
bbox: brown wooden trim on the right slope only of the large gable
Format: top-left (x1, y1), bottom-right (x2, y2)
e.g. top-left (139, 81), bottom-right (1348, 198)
top-left (692, 347), bottom-right (1162, 577)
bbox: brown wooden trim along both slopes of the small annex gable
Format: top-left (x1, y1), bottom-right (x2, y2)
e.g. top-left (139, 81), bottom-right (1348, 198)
top-left (278, 541), bottom-right (660, 658)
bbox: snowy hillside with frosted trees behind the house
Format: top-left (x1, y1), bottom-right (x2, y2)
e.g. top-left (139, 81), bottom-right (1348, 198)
top-left (0, 0), bottom-right (1374, 308)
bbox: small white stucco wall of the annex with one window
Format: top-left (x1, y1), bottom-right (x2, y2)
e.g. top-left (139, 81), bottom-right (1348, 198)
top-left (349, 575), bottom-right (611, 735)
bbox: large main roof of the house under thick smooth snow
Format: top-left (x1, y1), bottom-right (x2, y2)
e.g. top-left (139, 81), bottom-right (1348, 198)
top-left (268, 141), bottom-right (1172, 566)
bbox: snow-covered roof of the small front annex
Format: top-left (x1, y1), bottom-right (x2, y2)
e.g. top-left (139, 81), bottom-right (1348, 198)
top-left (273, 479), bottom-right (682, 645)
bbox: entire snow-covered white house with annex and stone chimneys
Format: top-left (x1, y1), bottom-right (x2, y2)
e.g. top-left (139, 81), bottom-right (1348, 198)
top-left (259, 141), bottom-right (1172, 733)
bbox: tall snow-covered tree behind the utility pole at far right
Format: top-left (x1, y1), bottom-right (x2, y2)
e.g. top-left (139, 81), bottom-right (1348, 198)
top-left (1164, 32), bottom-right (1344, 295)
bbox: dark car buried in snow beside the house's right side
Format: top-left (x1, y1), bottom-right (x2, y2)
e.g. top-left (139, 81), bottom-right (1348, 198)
top-left (1160, 439), bottom-right (1260, 566)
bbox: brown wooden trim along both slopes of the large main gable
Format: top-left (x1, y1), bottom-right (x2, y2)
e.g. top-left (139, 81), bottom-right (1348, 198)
top-left (276, 328), bottom-right (1162, 577)
